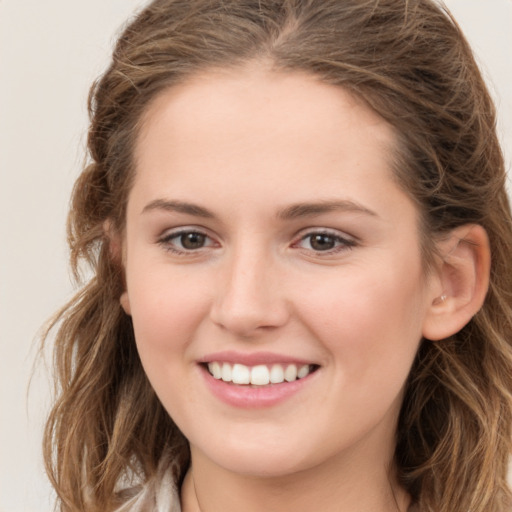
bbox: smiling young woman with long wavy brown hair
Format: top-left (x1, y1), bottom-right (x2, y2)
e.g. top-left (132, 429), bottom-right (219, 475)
top-left (45, 0), bottom-right (512, 512)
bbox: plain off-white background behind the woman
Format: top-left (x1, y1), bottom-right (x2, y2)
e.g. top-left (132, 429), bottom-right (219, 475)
top-left (0, 0), bottom-right (512, 512)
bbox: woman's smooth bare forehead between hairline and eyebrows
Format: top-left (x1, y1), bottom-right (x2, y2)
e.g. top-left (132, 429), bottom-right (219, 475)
top-left (130, 65), bottom-right (410, 223)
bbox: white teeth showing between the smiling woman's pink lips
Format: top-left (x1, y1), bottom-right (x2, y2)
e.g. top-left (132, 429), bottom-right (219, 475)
top-left (205, 361), bottom-right (319, 386)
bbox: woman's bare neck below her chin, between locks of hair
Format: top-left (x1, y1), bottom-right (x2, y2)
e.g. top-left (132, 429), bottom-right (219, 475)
top-left (181, 446), bottom-right (409, 512)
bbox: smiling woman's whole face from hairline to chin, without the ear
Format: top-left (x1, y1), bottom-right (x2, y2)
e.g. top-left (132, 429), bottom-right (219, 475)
top-left (122, 67), bottom-right (440, 476)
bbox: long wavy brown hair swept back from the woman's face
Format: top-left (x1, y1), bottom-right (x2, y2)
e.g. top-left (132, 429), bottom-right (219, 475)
top-left (44, 0), bottom-right (512, 512)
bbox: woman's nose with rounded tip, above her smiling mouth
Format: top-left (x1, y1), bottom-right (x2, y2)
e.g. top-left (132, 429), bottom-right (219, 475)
top-left (211, 248), bottom-right (289, 338)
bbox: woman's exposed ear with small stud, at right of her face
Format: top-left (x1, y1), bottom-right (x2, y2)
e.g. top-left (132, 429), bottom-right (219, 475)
top-left (423, 224), bottom-right (491, 340)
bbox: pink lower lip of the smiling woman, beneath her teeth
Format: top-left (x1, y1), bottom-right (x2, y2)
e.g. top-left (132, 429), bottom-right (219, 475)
top-left (200, 366), bottom-right (318, 409)
